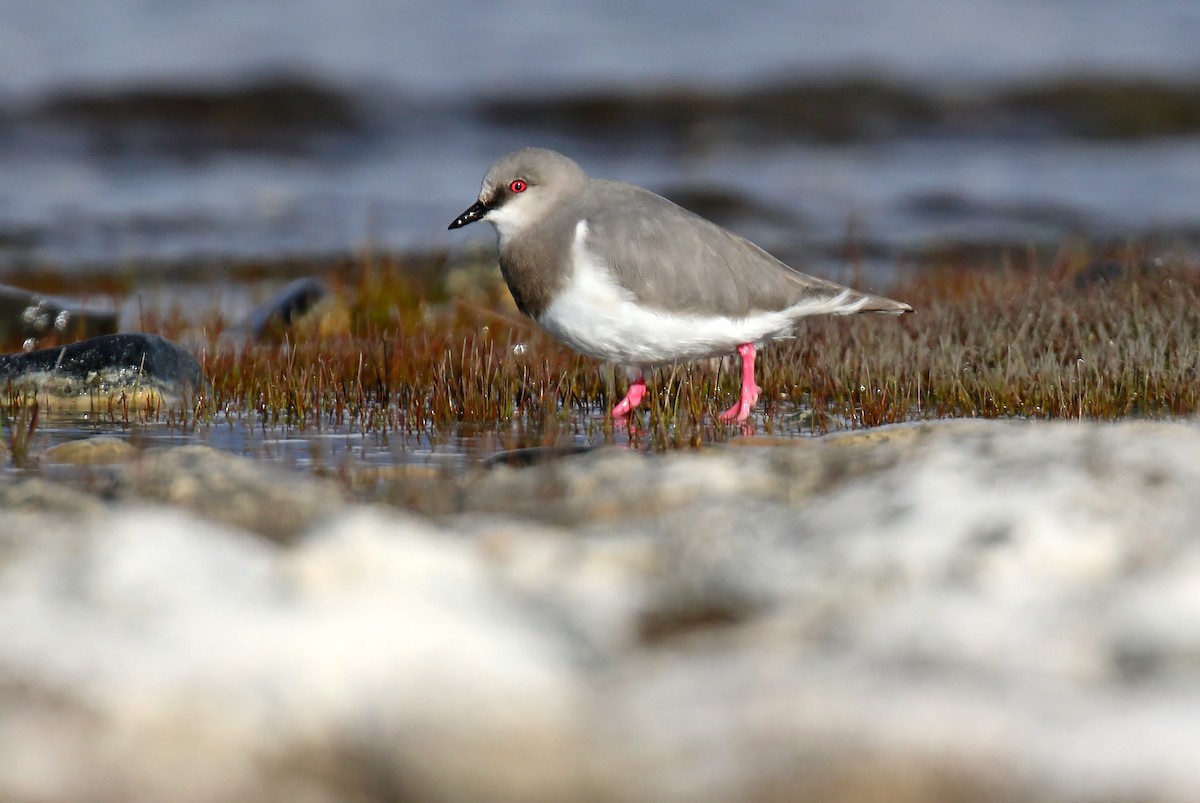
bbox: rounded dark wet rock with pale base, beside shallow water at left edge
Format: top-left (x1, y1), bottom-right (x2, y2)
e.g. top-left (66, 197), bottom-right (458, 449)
top-left (0, 334), bottom-right (204, 397)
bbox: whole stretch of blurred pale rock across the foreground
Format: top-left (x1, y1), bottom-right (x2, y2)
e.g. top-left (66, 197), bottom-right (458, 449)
top-left (0, 421), bottom-right (1200, 803)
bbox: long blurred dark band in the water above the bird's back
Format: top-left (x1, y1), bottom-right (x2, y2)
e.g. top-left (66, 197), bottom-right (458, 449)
top-left (479, 74), bottom-right (1200, 149)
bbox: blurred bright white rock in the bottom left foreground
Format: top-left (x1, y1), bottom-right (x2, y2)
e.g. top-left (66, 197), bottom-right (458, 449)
top-left (0, 510), bottom-right (578, 801)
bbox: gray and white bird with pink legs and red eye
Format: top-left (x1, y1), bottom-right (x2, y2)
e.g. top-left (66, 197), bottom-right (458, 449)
top-left (450, 148), bottom-right (912, 421)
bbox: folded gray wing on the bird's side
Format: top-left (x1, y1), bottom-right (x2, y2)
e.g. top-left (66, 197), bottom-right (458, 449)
top-left (582, 181), bottom-right (864, 317)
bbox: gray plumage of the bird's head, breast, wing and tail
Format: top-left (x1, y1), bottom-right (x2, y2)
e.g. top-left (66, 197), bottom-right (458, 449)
top-left (456, 148), bottom-right (912, 319)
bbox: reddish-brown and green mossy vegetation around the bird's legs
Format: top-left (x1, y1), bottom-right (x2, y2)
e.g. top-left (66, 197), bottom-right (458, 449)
top-left (6, 244), bottom-right (1200, 449)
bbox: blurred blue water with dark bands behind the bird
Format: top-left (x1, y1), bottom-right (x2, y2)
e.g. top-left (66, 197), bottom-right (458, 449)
top-left (0, 0), bottom-right (1200, 278)
